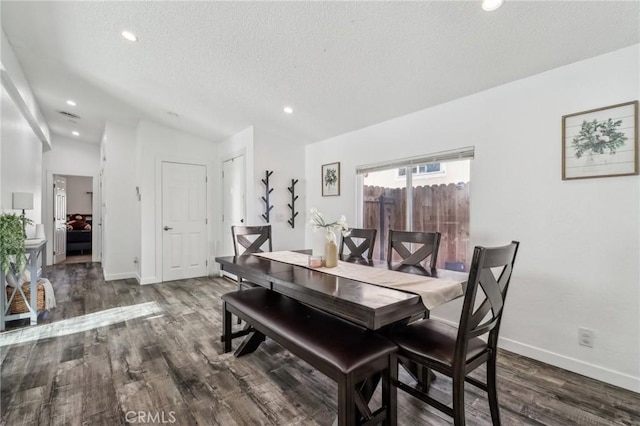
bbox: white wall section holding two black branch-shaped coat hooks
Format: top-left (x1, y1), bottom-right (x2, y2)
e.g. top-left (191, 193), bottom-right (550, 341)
top-left (252, 128), bottom-right (308, 250)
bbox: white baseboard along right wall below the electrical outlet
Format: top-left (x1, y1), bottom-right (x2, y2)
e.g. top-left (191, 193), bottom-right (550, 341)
top-left (498, 337), bottom-right (640, 393)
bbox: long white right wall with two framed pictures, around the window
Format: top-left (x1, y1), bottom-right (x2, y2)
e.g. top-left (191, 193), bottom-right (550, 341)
top-left (305, 45), bottom-right (640, 392)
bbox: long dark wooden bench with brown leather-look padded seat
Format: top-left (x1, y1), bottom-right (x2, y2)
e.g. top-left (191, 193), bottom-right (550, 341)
top-left (222, 287), bottom-right (397, 426)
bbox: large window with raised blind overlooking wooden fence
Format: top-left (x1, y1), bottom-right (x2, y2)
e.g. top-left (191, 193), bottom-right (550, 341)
top-left (358, 148), bottom-right (473, 271)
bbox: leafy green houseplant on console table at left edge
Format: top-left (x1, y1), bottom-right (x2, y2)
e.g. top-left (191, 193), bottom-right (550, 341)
top-left (0, 213), bottom-right (31, 274)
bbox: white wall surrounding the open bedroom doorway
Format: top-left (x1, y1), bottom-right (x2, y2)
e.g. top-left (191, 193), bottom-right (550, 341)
top-left (42, 135), bottom-right (102, 265)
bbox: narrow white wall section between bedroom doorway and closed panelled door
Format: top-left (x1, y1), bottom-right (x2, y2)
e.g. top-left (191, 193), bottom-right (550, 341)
top-left (101, 122), bottom-right (140, 280)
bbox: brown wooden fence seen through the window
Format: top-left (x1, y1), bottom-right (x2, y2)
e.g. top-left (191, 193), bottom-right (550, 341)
top-left (363, 183), bottom-right (470, 271)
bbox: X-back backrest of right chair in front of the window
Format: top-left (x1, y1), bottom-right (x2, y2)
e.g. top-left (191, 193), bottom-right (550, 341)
top-left (387, 229), bottom-right (440, 269)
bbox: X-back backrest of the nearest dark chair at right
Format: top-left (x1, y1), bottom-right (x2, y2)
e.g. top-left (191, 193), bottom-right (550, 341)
top-left (455, 241), bottom-right (520, 360)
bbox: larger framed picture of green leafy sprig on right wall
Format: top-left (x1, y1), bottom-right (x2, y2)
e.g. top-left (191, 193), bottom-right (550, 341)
top-left (562, 101), bottom-right (638, 180)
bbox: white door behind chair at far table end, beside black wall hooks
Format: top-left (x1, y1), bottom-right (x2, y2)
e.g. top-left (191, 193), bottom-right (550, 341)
top-left (222, 155), bottom-right (247, 256)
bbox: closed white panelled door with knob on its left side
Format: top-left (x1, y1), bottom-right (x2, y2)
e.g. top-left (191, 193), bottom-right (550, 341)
top-left (161, 162), bottom-right (207, 281)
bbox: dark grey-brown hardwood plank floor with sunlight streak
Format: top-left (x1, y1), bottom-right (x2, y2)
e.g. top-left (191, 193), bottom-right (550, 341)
top-left (0, 263), bottom-right (640, 426)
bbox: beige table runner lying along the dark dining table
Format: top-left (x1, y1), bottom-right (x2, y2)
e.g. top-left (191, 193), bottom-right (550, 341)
top-left (254, 251), bottom-right (464, 310)
